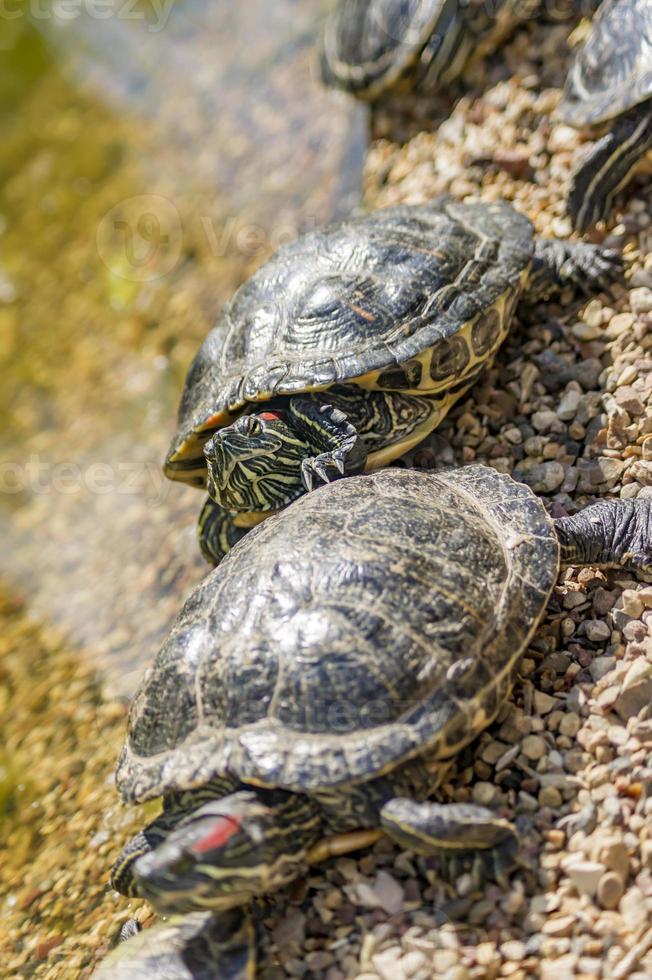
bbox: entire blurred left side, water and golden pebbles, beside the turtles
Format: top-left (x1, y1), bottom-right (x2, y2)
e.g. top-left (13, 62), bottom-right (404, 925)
top-left (0, 7), bottom-right (366, 968)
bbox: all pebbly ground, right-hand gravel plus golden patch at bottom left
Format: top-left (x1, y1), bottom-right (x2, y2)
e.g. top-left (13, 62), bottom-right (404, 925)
top-left (0, 9), bottom-right (652, 980)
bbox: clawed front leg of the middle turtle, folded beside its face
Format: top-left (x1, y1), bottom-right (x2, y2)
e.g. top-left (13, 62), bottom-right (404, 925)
top-left (290, 397), bottom-right (367, 490)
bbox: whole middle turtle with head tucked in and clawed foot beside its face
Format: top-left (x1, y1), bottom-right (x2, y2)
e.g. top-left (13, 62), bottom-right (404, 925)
top-left (165, 195), bottom-right (620, 564)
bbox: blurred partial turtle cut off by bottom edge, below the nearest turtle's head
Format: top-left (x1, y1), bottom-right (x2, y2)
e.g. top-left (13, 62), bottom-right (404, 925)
top-left (93, 909), bottom-right (257, 980)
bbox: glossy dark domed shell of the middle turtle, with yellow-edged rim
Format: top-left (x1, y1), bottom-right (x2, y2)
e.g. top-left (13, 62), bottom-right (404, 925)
top-left (166, 196), bottom-right (533, 483)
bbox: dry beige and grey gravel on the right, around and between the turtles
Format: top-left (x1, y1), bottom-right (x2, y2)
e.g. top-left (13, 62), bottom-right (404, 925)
top-left (258, 13), bottom-right (652, 980)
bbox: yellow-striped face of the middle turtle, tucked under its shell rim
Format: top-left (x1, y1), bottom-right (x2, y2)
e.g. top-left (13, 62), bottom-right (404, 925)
top-left (204, 410), bottom-right (310, 512)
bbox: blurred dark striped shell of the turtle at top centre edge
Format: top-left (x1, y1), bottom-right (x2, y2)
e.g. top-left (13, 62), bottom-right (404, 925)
top-left (321, 0), bottom-right (457, 98)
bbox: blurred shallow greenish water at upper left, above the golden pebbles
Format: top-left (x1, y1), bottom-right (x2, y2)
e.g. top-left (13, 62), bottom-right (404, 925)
top-left (0, 0), bottom-right (366, 693)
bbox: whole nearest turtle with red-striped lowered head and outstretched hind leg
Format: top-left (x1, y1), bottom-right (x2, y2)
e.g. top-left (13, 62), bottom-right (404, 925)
top-left (105, 464), bottom-right (652, 975)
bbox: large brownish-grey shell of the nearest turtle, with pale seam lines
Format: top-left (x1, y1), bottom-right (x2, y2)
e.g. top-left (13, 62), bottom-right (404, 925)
top-left (117, 465), bottom-right (559, 801)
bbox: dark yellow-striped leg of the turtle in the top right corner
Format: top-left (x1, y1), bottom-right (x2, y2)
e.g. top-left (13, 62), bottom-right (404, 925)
top-left (567, 99), bottom-right (652, 231)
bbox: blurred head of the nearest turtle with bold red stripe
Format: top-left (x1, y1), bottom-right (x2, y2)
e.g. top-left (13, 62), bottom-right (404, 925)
top-left (133, 789), bottom-right (319, 915)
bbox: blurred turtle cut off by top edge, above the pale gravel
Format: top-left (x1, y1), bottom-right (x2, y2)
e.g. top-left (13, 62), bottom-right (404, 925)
top-left (320, 0), bottom-right (586, 101)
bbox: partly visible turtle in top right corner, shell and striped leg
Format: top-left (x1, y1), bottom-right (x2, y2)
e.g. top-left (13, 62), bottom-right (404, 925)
top-left (559, 0), bottom-right (652, 231)
